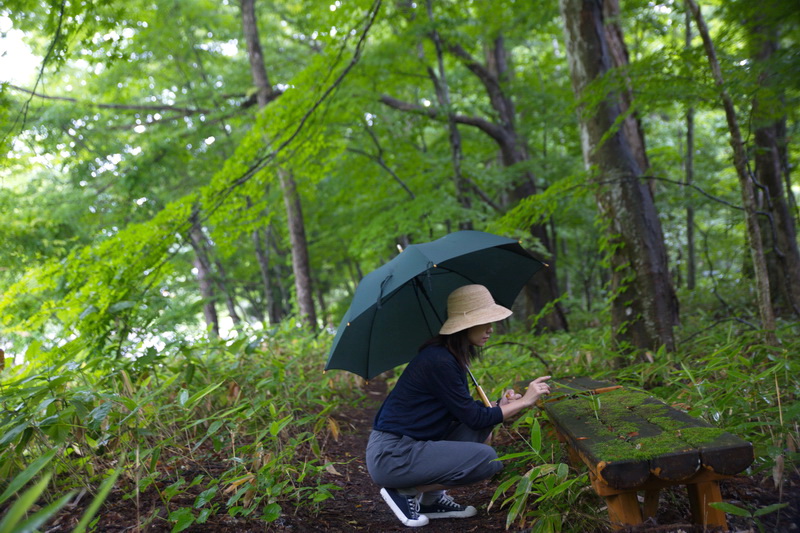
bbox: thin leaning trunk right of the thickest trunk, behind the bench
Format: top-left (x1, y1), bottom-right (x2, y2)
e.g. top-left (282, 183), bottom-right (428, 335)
top-left (686, 0), bottom-right (777, 344)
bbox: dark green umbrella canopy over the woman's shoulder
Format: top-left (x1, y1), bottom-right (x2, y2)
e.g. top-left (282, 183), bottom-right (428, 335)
top-left (325, 231), bottom-right (544, 379)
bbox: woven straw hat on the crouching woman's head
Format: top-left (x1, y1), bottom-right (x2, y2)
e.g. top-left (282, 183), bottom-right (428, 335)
top-left (439, 285), bottom-right (511, 335)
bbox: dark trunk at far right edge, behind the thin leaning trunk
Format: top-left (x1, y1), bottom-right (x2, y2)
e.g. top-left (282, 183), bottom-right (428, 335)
top-left (751, 25), bottom-right (800, 315)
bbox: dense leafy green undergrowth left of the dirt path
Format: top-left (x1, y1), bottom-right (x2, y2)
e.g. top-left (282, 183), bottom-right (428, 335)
top-left (0, 318), bottom-right (360, 531)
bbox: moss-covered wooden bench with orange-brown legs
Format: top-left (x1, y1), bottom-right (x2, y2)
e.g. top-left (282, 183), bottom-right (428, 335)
top-left (541, 378), bottom-right (753, 530)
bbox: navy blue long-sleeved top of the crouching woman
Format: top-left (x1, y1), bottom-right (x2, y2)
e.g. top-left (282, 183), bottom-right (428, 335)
top-left (373, 345), bottom-right (503, 440)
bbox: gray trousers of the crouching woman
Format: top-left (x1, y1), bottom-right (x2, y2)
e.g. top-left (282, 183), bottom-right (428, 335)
top-left (367, 424), bottom-right (503, 489)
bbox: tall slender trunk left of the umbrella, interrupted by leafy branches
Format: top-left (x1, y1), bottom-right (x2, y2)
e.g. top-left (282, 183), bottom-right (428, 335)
top-left (242, 0), bottom-right (317, 327)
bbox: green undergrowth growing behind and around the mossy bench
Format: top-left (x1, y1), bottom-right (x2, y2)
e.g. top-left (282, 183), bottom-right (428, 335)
top-left (474, 321), bottom-right (800, 533)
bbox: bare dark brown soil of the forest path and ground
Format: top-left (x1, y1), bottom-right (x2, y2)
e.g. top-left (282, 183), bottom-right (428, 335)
top-left (42, 381), bottom-right (800, 533)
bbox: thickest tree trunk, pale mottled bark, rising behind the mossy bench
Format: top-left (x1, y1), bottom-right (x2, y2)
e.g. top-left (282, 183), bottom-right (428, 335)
top-left (560, 0), bottom-right (678, 350)
